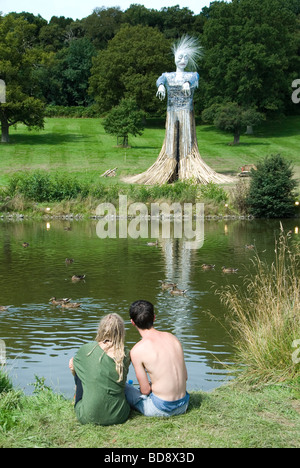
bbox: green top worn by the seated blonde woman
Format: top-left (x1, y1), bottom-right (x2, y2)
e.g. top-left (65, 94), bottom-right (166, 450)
top-left (74, 341), bottom-right (130, 426)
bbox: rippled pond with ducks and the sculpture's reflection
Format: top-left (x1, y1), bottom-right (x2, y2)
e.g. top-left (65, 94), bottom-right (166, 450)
top-left (0, 220), bottom-right (300, 398)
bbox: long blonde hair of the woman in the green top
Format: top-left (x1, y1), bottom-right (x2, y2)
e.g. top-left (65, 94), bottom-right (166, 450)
top-left (96, 314), bottom-right (125, 382)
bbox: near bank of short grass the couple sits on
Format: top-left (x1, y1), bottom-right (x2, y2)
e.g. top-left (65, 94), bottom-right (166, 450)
top-left (0, 374), bottom-right (300, 449)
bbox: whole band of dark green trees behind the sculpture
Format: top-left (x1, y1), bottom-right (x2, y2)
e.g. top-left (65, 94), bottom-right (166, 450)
top-left (0, 0), bottom-right (300, 141)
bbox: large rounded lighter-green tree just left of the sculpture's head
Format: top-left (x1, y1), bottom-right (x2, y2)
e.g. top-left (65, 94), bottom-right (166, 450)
top-left (90, 25), bottom-right (174, 112)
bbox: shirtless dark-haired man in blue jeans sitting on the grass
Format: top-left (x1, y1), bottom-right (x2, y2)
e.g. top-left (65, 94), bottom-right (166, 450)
top-left (125, 301), bottom-right (189, 416)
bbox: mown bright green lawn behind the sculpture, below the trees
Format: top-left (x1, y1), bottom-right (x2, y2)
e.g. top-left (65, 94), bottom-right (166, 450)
top-left (0, 116), bottom-right (300, 185)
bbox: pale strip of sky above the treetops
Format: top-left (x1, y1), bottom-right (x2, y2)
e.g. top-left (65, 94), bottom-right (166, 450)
top-left (0, 0), bottom-right (211, 21)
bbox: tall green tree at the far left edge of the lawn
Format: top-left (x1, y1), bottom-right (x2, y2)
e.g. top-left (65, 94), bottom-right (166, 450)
top-left (0, 15), bottom-right (44, 143)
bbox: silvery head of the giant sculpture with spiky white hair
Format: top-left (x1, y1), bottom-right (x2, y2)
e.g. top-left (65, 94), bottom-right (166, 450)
top-left (172, 36), bottom-right (202, 71)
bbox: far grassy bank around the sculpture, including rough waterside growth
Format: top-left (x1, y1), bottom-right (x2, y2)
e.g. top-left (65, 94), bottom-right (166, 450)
top-left (0, 116), bottom-right (300, 217)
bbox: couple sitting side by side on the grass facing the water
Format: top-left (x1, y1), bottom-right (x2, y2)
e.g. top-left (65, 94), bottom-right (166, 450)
top-left (69, 301), bottom-right (189, 426)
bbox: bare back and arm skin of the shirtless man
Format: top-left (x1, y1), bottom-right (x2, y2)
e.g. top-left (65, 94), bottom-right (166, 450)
top-left (130, 328), bottom-right (187, 401)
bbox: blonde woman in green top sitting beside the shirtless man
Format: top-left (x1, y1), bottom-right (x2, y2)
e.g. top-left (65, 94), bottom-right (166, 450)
top-left (69, 314), bottom-right (130, 426)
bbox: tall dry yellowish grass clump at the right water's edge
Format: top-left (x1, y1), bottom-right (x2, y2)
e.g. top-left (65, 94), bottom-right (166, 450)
top-left (219, 228), bottom-right (300, 385)
